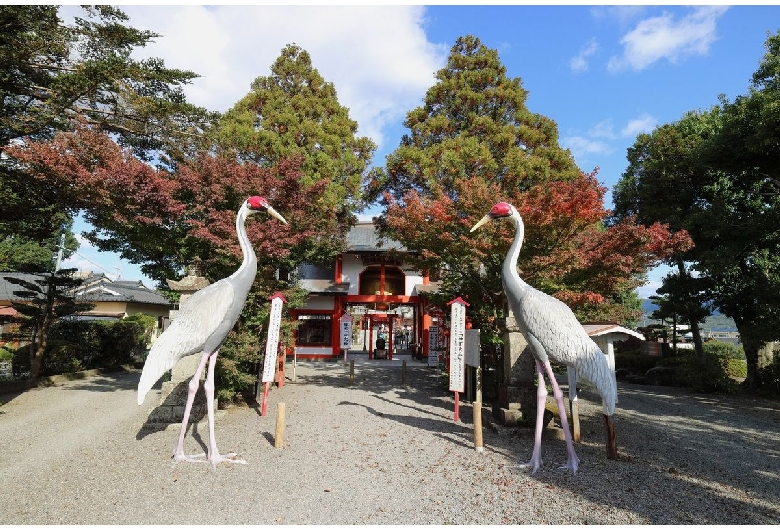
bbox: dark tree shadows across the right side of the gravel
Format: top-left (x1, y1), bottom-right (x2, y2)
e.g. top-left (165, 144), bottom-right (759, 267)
top-left (288, 358), bottom-right (780, 524)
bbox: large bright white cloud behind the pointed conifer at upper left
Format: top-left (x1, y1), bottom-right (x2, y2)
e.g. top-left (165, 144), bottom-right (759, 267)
top-left (122, 5), bottom-right (442, 153)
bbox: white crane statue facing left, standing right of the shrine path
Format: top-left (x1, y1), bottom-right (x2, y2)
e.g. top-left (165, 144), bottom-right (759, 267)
top-left (471, 202), bottom-right (617, 474)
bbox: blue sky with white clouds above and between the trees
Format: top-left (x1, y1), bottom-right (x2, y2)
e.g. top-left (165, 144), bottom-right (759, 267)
top-left (59, 5), bottom-right (780, 296)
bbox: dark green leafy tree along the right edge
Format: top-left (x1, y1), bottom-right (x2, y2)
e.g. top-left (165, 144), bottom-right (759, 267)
top-left (615, 33), bottom-right (780, 390)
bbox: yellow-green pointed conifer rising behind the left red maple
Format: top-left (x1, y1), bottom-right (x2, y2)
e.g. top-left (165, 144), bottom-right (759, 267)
top-left (216, 44), bottom-right (377, 240)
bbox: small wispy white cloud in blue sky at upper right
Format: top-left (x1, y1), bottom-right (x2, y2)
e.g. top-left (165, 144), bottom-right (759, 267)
top-left (607, 6), bottom-right (728, 72)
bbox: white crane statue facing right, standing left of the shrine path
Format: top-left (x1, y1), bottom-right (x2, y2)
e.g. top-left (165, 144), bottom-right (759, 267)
top-left (138, 196), bottom-right (287, 467)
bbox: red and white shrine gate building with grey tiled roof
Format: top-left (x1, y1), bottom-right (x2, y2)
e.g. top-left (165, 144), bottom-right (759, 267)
top-left (288, 222), bottom-right (443, 360)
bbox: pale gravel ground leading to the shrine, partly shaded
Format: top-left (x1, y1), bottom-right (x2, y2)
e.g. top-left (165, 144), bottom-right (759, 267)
top-left (0, 361), bottom-right (780, 524)
